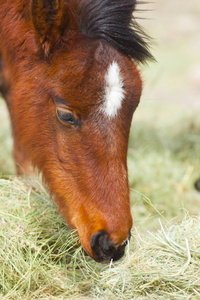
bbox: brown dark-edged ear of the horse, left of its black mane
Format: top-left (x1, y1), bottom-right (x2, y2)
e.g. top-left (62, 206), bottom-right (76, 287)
top-left (31, 0), bottom-right (72, 56)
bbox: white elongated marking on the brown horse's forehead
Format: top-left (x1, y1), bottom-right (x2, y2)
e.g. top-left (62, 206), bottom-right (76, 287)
top-left (103, 61), bottom-right (125, 118)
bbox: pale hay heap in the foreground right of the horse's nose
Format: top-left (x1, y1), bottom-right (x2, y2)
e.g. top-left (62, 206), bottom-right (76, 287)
top-left (97, 217), bottom-right (200, 299)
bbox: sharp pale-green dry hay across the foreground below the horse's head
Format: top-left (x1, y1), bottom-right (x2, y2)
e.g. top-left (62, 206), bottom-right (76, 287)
top-left (0, 178), bottom-right (200, 300)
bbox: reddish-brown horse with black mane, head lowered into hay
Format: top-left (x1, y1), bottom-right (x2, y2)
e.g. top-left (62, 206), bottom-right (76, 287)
top-left (0, 0), bottom-right (151, 261)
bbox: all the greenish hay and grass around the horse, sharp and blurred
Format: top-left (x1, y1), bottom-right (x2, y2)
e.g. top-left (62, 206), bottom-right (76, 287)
top-left (0, 96), bottom-right (200, 300)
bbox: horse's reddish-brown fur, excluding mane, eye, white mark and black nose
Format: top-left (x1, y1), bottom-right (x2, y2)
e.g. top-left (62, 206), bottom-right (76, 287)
top-left (0, 0), bottom-right (141, 257)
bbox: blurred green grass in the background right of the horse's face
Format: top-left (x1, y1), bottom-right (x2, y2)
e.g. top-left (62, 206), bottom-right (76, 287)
top-left (128, 102), bottom-right (200, 228)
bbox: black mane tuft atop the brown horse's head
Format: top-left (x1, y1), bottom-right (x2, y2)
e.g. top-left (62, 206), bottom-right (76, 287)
top-left (79, 0), bottom-right (153, 63)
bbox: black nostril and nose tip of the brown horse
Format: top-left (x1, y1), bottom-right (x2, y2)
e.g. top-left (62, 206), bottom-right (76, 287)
top-left (90, 230), bottom-right (130, 262)
